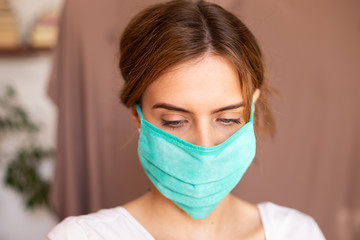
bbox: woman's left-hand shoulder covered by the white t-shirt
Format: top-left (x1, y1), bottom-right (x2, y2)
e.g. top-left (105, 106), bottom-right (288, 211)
top-left (47, 207), bottom-right (153, 240)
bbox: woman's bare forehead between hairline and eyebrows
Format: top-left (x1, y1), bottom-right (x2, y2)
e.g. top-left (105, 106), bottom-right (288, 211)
top-left (142, 55), bottom-right (242, 110)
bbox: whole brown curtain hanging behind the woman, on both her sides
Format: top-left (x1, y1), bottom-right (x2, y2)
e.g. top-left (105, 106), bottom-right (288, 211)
top-left (49, 0), bottom-right (360, 240)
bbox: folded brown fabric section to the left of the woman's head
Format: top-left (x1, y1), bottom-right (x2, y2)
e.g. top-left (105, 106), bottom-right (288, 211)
top-left (49, 0), bottom-right (153, 218)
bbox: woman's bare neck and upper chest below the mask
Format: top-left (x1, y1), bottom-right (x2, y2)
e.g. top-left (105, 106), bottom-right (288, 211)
top-left (123, 187), bottom-right (265, 240)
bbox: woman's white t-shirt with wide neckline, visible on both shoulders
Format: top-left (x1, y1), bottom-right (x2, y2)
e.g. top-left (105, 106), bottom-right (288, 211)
top-left (48, 202), bottom-right (325, 240)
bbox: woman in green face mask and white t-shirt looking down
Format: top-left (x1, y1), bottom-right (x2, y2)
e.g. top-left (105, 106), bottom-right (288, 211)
top-left (48, 0), bottom-right (324, 240)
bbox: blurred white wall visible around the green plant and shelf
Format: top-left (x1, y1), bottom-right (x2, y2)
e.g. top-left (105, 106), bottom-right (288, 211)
top-left (0, 0), bottom-right (62, 240)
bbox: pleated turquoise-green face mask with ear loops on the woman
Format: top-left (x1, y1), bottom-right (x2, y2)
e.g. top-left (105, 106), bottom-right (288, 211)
top-left (136, 105), bottom-right (256, 219)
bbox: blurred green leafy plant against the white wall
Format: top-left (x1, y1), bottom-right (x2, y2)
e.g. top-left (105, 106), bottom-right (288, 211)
top-left (0, 86), bottom-right (52, 208)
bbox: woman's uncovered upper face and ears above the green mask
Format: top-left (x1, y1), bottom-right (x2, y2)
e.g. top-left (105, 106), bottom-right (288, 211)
top-left (133, 54), bottom-right (259, 147)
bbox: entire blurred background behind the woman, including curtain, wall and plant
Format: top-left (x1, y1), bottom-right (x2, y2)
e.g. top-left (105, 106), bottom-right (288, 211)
top-left (0, 0), bottom-right (360, 240)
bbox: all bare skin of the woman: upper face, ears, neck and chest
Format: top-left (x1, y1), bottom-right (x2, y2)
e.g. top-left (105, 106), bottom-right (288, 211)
top-left (124, 54), bottom-right (265, 240)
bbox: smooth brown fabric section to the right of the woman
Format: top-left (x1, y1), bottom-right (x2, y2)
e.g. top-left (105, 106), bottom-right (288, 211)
top-left (234, 0), bottom-right (360, 239)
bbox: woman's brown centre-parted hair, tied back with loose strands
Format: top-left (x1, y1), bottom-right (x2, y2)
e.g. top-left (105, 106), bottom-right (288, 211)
top-left (119, 0), bottom-right (274, 134)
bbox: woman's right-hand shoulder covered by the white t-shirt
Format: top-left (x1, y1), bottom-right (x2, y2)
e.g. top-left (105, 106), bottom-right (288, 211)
top-left (257, 202), bottom-right (325, 239)
